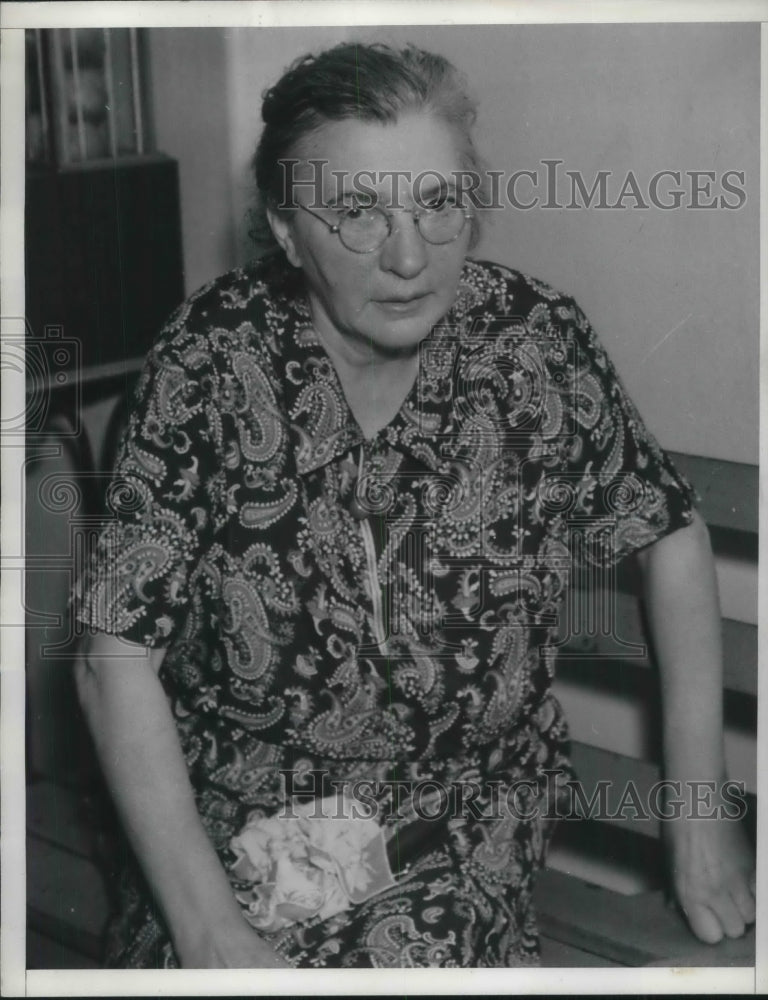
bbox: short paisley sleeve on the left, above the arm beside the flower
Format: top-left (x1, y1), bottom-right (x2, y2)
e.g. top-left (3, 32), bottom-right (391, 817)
top-left (73, 329), bottom-right (221, 646)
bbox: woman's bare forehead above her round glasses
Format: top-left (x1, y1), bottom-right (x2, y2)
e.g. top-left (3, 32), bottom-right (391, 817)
top-left (293, 112), bottom-right (463, 201)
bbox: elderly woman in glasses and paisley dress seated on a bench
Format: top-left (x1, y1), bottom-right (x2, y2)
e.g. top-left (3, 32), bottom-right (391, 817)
top-left (77, 45), bottom-right (754, 967)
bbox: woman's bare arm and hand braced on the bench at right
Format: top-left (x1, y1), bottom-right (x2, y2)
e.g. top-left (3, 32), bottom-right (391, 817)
top-left (638, 513), bottom-right (755, 943)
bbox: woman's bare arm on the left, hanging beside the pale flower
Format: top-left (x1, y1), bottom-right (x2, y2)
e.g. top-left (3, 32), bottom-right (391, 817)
top-left (75, 632), bottom-right (290, 968)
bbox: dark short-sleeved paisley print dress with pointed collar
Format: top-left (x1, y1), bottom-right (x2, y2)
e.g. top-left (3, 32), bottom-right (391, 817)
top-left (78, 260), bottom-right (692, 967)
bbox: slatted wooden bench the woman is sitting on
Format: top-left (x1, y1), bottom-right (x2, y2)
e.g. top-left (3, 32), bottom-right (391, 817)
top-left (27, 455), bottom-right (758, 968)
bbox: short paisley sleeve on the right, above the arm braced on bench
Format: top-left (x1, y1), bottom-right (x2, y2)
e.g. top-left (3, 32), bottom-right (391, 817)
top-left (556, 300), bottom-right (695, 562)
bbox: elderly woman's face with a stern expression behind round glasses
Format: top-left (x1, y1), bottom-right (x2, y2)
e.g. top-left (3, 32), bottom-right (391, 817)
top-left (270, 113), bottom-right (471, 359)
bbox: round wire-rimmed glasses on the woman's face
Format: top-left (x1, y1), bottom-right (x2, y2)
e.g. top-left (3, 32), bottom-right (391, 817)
top-left (298, 201), bottom-right (472, 253)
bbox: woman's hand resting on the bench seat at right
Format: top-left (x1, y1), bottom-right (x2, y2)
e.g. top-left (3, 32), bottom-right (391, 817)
top-left (664, 818), bottom-right (755, 944)
